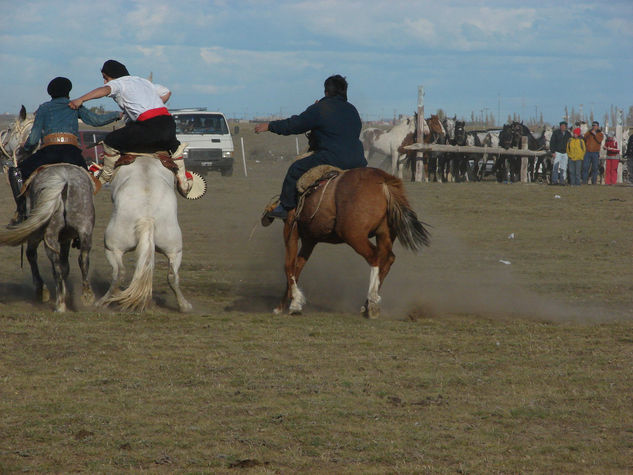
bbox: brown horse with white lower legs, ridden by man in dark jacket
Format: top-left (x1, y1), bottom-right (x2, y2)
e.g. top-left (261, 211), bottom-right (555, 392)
top-left (275, 168), bottom-right (429, 318)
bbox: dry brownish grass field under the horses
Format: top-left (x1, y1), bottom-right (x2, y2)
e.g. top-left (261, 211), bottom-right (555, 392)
top-left (0, 126), bottom-right (633, 473)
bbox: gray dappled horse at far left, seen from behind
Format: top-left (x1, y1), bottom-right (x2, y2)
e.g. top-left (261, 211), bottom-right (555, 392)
top-left (0, 106), bottom-right (95, 312)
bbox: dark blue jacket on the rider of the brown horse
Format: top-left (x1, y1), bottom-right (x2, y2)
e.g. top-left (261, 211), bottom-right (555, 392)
top-left (268, 96), bottom-right (367, 170)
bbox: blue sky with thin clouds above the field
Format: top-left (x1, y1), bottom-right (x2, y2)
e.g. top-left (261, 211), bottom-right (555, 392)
top-left (0, 0), bottom-right (633, 122)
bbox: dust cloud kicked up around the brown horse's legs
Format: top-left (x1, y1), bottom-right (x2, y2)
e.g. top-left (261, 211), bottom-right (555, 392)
top-left (234, 218), bottom-right (623, 322)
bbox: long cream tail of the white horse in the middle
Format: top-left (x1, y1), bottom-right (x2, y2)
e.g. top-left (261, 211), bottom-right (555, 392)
top-left (107, 217), bottom-right (155, 312)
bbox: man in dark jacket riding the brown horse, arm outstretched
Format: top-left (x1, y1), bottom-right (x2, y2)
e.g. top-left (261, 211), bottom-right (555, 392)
top-left (255, 75), bottom-right (367, 219)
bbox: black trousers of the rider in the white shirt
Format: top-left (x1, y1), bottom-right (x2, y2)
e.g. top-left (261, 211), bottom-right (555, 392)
top-left (103, 115), bottom-right (180, 153)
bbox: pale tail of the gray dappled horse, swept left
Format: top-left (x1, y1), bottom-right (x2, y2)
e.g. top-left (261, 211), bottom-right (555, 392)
top-left (0, 174), bottom-right (68, 246)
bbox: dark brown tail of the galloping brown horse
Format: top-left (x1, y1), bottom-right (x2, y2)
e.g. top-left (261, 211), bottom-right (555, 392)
top-left (383, 176), bottom-right (431, 252)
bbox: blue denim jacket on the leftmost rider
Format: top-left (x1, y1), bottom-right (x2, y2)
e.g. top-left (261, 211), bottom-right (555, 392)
top-left (24, 97), bottom-right (121, 152)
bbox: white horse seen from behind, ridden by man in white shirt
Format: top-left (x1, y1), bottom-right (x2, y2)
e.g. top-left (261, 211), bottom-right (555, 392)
top-left (97, 156), bottom-right (192, 312)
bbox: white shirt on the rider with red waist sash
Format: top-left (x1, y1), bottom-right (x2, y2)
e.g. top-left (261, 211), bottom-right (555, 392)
top-left (106, 76), bottom-right (169, 121)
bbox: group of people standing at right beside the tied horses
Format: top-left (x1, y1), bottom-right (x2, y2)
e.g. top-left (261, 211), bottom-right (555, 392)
top-left (550, 121), bottom-right (633, 186)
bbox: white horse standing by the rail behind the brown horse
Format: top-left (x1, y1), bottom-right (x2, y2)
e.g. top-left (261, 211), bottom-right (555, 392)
top-left (360, 117), bottom-right (430, 176)
